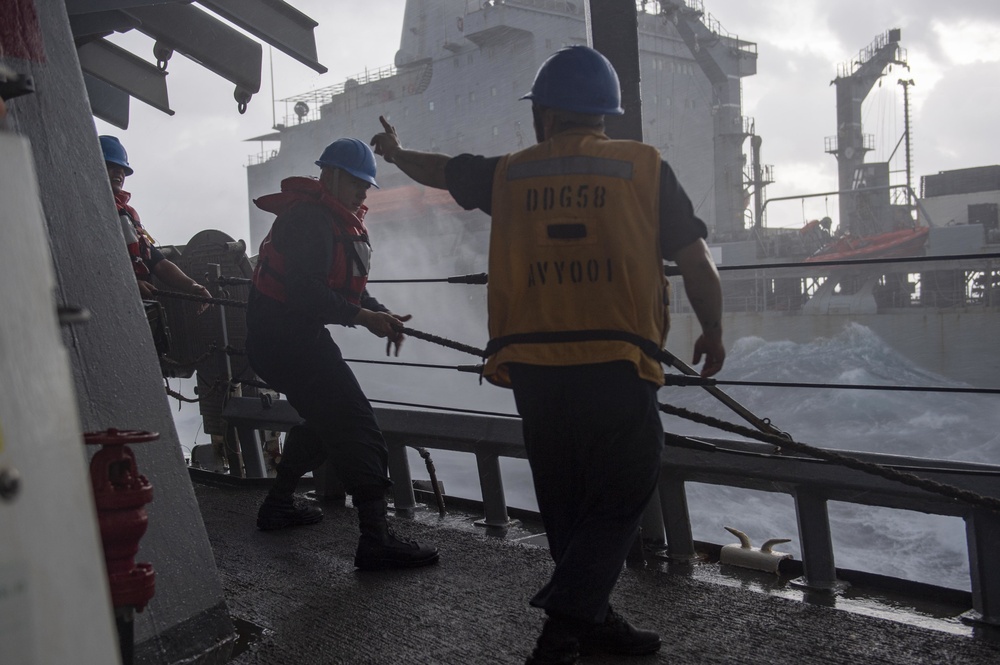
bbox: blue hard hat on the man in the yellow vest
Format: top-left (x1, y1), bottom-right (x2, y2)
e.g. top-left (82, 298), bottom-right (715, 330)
top-left (521, 46), bottom-right (625, 115)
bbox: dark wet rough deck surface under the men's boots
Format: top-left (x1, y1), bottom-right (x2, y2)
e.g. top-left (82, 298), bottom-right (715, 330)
top-left (195, 484), bottom-right (1000, 665)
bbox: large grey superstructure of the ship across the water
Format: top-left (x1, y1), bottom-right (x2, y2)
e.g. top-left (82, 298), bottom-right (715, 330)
top-left (247, 0), bottom-right (757, 251)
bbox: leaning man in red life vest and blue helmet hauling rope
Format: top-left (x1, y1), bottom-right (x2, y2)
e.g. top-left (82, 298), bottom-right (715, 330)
top-left (246, 138), bottom-right (438, 570)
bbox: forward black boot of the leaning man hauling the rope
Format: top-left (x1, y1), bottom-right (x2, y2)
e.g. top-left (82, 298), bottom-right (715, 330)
top-left (354, 495), bottom-right (438, 570)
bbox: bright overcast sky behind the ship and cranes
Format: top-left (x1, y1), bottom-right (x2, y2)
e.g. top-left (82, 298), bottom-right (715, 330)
top-left (95, 0), bottom-right (1000, 245)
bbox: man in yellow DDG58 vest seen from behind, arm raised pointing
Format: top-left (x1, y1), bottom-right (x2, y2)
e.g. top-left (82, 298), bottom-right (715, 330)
top-left (371, 46), bottom-right (726, 665)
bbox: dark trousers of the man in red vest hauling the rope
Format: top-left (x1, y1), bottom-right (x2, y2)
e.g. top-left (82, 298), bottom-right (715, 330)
top-left (247, 329), bottom-right (391, 494)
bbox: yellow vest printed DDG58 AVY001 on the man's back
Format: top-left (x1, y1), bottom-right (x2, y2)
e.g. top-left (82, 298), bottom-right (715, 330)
top-left (483, 128), bottom-right (669, 386)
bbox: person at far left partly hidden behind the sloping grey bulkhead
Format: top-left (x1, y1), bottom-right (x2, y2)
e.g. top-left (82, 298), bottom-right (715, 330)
top-left (99, 136), bottom-right (212, 314)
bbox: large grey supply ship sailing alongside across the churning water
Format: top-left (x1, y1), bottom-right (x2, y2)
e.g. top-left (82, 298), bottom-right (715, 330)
top-left (247, 0), bottom-right (1000, 385)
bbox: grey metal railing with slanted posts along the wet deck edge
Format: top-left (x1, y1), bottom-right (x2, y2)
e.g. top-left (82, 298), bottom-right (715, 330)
top-left (375, 408), bottom-right (1000, 625)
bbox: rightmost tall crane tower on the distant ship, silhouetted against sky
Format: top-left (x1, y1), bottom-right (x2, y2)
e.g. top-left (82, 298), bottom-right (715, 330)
top-left (826, 28), bottom-right (909, 236)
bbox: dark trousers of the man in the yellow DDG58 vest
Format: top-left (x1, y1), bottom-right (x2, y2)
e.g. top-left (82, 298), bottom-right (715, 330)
top-left (510, 361), bottom-right (663, 623)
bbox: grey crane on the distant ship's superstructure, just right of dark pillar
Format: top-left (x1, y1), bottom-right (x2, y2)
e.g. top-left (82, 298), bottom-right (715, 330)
top-left (660, 0), bottom-right (760, 241)
